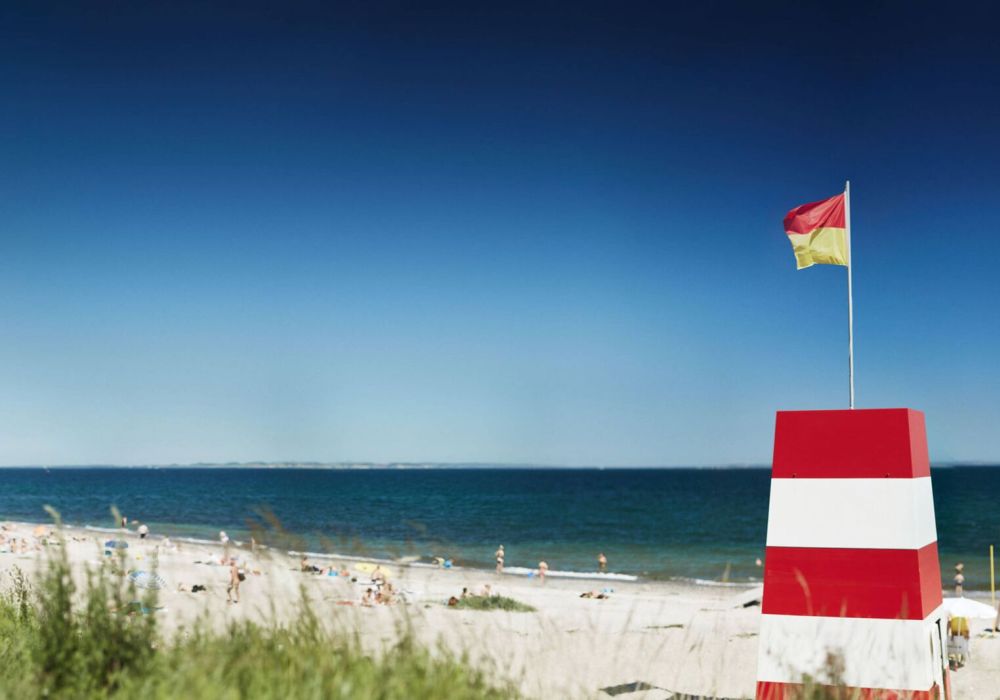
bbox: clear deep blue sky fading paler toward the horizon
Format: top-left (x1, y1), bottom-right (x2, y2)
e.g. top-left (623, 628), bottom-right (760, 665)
top-left (0, 1), bottom-right (1000, 465)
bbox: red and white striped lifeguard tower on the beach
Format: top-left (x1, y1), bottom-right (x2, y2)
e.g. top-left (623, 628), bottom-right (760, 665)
top-left (757, 408), bottom-right (950, 700)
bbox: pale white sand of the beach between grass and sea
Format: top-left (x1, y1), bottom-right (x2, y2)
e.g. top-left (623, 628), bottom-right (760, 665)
top-left (0, 524), bottom-right (1000, 700)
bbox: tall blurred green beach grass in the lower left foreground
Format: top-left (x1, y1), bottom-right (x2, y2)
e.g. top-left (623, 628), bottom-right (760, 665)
top-left (0, 532), bottom-right (517, 700)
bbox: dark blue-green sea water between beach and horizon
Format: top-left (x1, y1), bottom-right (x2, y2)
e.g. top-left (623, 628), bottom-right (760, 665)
top-left (0, 467), bottom-right (1000, 590)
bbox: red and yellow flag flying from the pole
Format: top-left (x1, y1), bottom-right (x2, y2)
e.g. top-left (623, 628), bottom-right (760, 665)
top-left (785, 194), bottom-right (850, 270)
